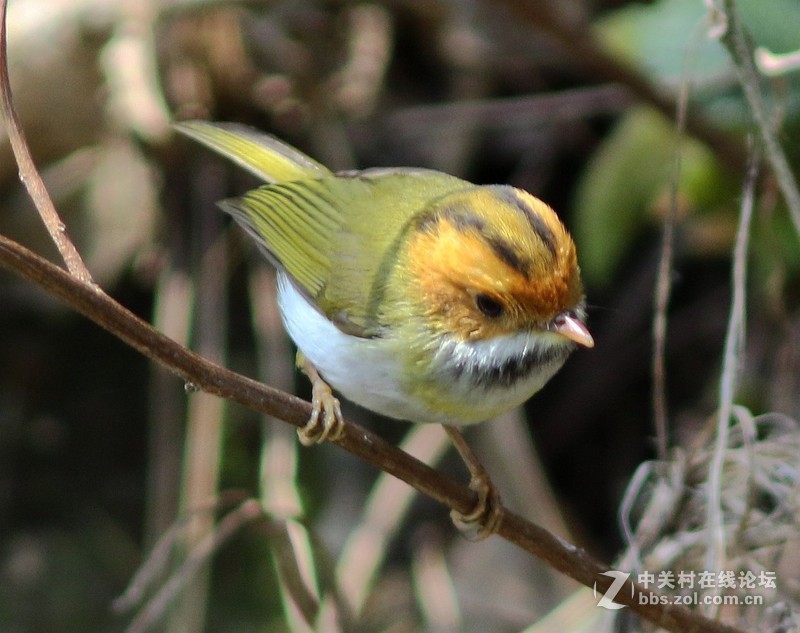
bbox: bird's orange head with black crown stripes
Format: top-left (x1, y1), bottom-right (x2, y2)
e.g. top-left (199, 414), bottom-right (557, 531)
top-left (408, 186), bottom-right (590, 344)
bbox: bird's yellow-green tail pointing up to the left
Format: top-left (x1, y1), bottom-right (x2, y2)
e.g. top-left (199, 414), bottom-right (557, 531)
top-left (174, 121), bottom-right (331, 182)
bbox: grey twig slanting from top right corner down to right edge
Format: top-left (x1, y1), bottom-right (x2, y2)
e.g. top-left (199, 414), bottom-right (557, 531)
top-left (720, 0), bottom-right (800, 237)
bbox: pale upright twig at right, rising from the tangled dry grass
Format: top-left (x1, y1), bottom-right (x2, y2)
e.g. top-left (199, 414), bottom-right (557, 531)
top-left (706, 141), bottom-right (760, 608)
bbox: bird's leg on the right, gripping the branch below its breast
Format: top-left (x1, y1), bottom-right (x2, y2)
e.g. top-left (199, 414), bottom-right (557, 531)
top-left (442, 424), bottom-right (503, 541)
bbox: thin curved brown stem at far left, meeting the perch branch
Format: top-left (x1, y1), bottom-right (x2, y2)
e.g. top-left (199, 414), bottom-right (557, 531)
top-left (0, 0), bottom-right (94, 284)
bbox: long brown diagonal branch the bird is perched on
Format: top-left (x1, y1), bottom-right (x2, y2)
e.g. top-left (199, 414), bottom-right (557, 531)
top-left (0, 236), bottom-right (752, 633)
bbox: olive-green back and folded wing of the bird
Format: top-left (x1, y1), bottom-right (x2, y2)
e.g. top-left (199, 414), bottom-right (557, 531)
top-left (220, 169), bottom-right (471, 336)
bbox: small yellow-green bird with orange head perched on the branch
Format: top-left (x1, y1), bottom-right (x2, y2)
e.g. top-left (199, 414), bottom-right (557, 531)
top-left (175, 120), bottom-right (594, 528)
